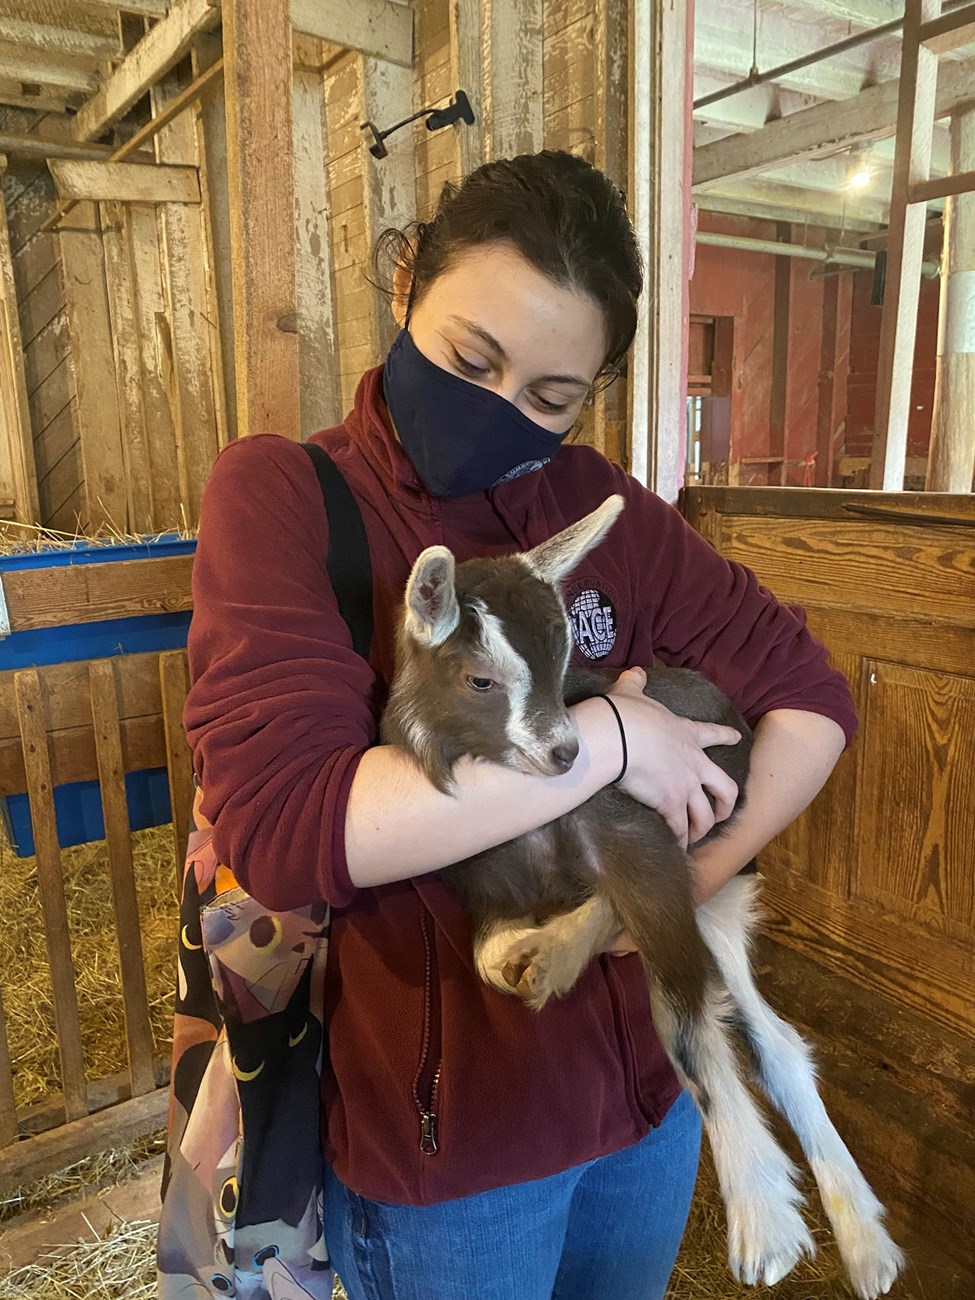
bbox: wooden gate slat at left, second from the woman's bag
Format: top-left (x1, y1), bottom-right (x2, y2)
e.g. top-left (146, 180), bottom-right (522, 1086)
top-left (88, 659), bottom-right (156, 1097)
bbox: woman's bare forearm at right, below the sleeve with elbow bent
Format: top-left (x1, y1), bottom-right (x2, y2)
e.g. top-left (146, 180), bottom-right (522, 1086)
top-left (693, 709), bottom-right (845, 904)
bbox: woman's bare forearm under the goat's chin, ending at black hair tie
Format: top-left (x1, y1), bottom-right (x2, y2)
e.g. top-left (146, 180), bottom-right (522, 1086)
top-left (346, 699), bottom-right (620, 888)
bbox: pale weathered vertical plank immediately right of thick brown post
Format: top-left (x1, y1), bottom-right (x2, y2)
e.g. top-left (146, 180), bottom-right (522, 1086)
top-left (294, 58), bottom-right (342, 437)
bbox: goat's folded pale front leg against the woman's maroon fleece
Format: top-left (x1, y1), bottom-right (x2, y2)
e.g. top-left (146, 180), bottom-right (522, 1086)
top-left (475, 894), bottom-right (620, 1011)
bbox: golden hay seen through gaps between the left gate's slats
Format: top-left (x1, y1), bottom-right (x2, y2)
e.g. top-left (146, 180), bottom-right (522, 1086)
top-left (0, 826), bottom-right (178, 1106)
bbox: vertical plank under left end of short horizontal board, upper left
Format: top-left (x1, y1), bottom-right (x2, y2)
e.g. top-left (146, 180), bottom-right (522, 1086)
top-left (59, 203), bottom-right (129, 533)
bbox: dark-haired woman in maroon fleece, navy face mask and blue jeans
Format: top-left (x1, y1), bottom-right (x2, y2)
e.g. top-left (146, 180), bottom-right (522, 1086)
top-left (185, 152), bottom-right (855, 1300)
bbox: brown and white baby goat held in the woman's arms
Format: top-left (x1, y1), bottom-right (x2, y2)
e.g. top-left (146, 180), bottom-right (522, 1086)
top-left (382, 497), bottom-right (904, 1300)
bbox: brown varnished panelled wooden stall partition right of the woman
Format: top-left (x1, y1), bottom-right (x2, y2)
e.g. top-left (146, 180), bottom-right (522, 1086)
top-left (684, 488), bottom-right (975, 1248)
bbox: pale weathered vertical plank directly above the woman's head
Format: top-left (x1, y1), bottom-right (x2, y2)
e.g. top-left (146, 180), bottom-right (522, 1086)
top-left (482, 0), bottom-right (545, 160)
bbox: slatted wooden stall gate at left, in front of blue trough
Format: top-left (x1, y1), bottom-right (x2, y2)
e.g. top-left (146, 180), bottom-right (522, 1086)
top-left (0, 555), bottom-right (192, 1196)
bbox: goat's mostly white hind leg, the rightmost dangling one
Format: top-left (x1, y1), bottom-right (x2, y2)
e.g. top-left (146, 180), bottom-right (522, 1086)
top-left (697, 876), bottom-right (904, 1300)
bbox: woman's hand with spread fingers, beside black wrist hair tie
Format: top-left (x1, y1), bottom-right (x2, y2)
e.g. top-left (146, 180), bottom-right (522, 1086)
top-left (608, 668), bottom-right (741, 849)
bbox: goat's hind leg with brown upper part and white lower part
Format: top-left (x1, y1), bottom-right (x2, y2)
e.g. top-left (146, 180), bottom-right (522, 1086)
top-left (607, 862), bottom-right (815, 1286)
